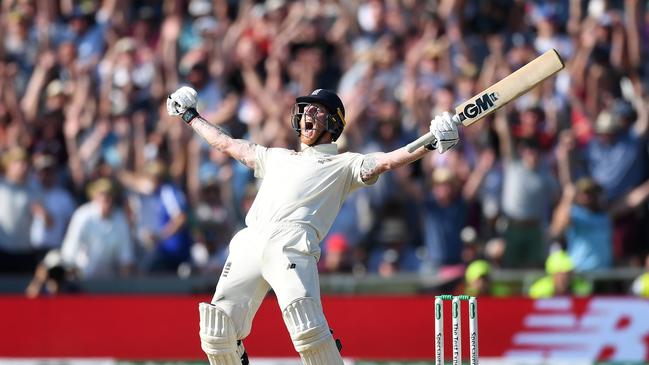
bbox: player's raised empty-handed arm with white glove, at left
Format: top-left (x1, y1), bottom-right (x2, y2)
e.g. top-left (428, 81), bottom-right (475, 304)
top-left (167, 86), bottom-right (257, 169)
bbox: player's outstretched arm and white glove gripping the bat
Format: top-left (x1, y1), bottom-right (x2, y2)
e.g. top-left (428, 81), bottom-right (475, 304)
top-left (361, 112), bottom-right (459, 181)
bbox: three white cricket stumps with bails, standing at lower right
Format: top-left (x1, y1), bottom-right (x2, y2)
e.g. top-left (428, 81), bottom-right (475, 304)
top-left (435, 295), bottom-right (478, 365)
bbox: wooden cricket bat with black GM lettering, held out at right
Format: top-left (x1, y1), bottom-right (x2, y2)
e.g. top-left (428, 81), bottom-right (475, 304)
top-left (406, 49), bottom-right (564, 153)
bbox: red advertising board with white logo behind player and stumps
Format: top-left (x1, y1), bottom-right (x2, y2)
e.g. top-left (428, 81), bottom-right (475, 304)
top-left (0, 296), bottom-right (649, 361)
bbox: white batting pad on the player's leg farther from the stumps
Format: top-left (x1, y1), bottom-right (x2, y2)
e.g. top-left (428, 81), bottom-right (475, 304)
top-left (198, 303), bottom-right (241, 365)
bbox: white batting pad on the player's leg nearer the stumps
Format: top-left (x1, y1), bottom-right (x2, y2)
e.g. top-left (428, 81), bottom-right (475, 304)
top-left (283, 298), bottom-right (343, 365)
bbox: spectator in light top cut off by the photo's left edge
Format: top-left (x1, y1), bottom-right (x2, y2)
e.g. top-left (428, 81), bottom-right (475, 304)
top-left (0, 147), bottom-right (44, 273)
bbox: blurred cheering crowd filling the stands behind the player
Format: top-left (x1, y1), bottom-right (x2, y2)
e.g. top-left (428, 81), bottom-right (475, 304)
top-left (0, 0), bottom-right (649, 291)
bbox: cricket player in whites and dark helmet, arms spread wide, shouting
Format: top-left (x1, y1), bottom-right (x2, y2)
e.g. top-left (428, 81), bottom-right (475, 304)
top-left (167, 87), bottom-right (459, 365)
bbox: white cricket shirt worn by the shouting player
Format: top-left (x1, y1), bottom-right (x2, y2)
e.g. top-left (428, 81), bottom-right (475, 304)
top-left (246, 143), bottom-right (378, 240)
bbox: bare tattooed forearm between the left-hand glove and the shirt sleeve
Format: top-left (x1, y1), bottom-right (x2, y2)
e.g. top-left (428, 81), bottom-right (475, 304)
top-left (191, 117), bottom-right (257, 169)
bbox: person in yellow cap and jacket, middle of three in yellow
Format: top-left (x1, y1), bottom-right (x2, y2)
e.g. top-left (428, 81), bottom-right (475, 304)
top-left (529, 251), bottom-right (593, 299)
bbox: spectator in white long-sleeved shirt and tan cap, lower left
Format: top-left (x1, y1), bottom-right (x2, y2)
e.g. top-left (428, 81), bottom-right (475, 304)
top-left (61, 178), bottom-right (135, 279)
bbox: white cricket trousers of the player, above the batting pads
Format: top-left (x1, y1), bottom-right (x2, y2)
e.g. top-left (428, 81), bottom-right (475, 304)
top-left (212, 224), bottom-right (340, 346)
